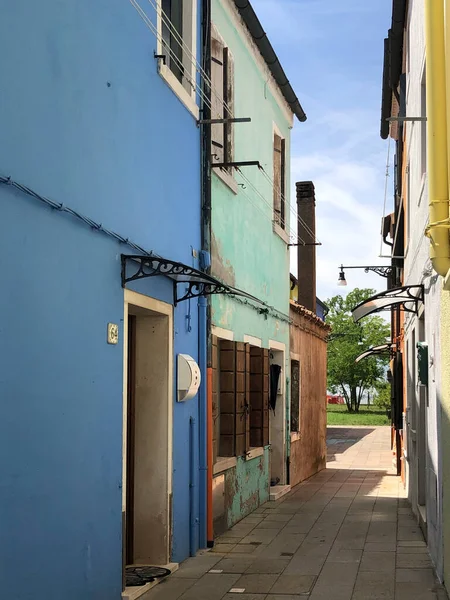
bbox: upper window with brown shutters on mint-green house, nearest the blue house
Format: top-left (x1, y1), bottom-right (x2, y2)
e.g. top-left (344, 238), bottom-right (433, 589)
top-left (211, 25), bottom-right (234, 172)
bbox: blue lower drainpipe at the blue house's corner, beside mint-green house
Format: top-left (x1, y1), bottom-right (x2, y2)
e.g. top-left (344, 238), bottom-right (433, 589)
top-left (198, 296), bottom-right (209, 548)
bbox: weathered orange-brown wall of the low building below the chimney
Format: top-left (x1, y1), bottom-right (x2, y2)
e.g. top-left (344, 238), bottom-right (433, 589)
top-left (290, 302), bottom-right (329, 485)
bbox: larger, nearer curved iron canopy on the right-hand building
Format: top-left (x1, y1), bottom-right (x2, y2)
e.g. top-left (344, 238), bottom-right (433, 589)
top-left (352, 285), bottom-right (423, 323)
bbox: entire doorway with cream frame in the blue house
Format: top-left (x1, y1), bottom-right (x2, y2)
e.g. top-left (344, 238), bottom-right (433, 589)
top-left (122, 290), bottom-right (173, 566)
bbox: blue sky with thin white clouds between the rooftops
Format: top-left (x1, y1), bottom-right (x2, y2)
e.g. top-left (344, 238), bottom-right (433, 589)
top-left (252, 0), bottom-right (393, 300)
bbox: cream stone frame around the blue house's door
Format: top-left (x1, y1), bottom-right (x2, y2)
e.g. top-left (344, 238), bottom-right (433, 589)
top-left (122, 289), bottom-right (174, 563)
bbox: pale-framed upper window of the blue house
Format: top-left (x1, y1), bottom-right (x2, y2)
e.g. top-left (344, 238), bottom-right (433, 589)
top-left (157, 0), bottom-right (198, 118)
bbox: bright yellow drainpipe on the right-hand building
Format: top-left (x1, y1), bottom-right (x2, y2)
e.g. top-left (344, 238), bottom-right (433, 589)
top-left (425, 0), bottom-right (450, 277)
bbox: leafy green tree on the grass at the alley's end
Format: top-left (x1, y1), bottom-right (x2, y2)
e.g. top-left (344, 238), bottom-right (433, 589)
top-left (327, 288), bottom-right (390, 412)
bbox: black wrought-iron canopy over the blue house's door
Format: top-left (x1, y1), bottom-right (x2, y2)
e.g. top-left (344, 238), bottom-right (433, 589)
top-left (121, 254), bottom-right (264, 305)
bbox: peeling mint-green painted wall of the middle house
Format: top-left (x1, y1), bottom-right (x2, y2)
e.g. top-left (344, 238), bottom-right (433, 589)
top-left (211, 0), bottom-right (292, 527)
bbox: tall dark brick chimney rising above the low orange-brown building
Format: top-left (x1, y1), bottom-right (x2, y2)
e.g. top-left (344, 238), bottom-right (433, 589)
top-left (296, 181), bottom-right (316, 314)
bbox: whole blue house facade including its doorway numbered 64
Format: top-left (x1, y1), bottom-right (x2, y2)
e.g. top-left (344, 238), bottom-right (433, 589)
top-left (0, 0), bottom-right (206, 600)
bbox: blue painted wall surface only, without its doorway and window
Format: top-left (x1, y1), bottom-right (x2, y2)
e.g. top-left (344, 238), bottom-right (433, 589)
top-left (0, 0), bottom-right (201, 600)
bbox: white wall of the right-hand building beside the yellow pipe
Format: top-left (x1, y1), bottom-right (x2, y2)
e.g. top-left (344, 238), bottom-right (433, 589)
top-left (404, 0), bottom-right (443, 577)
